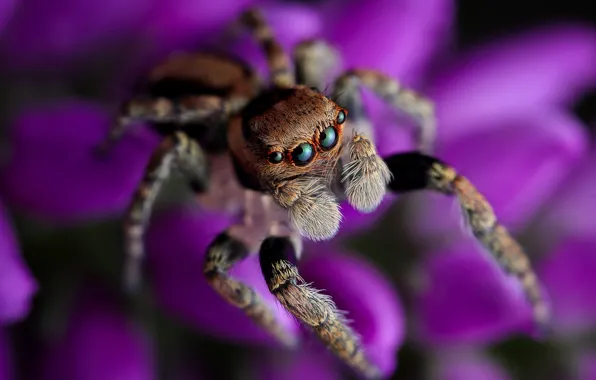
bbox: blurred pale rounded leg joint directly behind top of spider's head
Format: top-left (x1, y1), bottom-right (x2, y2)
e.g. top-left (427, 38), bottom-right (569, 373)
top-left (294, 40), bottom-right (340, 91)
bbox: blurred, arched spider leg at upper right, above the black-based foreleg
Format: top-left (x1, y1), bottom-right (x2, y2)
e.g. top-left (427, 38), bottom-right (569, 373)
top-left (333, 70), bottom-right (436, 153)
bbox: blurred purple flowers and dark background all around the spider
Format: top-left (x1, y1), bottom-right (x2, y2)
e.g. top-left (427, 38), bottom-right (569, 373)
top-left (0, 0), bottom-right (596, 380)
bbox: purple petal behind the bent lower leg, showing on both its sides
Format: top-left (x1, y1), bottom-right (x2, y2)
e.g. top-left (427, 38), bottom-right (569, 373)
top-left (147, 206), bottom-right (298, 344)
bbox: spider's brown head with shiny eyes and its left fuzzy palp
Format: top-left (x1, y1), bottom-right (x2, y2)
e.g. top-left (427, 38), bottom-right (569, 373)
top-left (242, 86), bottom-right (347, 240)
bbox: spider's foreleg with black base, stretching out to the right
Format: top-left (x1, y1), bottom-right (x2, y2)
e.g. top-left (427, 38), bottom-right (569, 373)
top-left (385, 152), bottom-right (550, 331)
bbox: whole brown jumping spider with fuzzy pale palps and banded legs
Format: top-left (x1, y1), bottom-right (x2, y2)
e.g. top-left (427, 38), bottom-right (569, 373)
top-left (96, 9), bottom-right (549, 379)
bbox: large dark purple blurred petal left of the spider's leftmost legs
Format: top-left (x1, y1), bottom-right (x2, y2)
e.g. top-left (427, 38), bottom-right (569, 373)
top-left (0, 101), bottom-right (157, 222)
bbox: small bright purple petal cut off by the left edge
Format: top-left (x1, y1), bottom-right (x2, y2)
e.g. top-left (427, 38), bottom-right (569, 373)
top-left (0, 205), bottom-right (37, 324)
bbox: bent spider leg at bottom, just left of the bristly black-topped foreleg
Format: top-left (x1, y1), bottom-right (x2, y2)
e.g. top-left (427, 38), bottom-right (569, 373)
top-left (203, 191), bottom-right (297, 347)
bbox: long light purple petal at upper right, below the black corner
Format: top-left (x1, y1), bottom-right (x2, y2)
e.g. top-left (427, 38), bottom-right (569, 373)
top-left (428, 25), bottom-right (596, 138)
